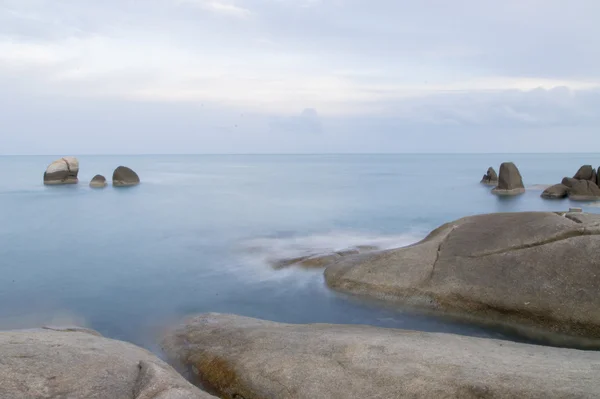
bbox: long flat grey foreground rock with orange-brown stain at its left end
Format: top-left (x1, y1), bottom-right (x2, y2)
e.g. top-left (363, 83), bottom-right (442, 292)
top-left (164, 314), bottom-right (600, 399)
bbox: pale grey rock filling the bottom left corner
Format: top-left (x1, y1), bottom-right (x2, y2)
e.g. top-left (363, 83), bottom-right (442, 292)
top-left (0, 328), bottom-right (212, 399)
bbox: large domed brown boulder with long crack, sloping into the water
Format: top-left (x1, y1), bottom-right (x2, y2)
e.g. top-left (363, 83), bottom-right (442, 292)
top-left (325, 212), bottom-right (600, 347)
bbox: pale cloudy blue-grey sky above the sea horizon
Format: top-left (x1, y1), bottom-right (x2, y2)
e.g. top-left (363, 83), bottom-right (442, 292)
top-left (0, 0), bottom-right (600, 155)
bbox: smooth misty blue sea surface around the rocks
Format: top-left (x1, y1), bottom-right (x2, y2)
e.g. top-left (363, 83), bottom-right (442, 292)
top-left (0, 154), bottom-right (600, 351)
